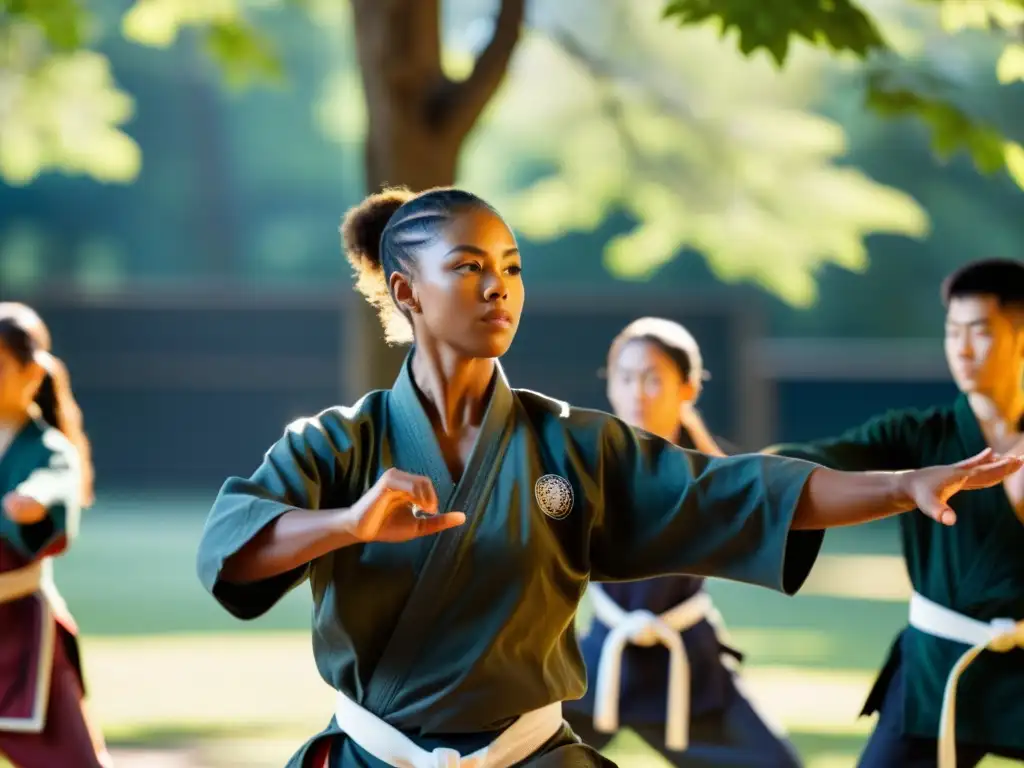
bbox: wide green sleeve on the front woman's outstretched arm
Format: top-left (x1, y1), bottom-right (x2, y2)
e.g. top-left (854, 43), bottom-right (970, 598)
top-left (591, 419), bottom-right (823, 594)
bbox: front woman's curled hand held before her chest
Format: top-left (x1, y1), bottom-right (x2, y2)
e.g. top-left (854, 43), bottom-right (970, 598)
top-left (346, 468), bottom-right (466, 543)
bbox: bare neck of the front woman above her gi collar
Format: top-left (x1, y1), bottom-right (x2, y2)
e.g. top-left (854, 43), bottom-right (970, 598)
top-left (412, 343), bottom-right (495, 434)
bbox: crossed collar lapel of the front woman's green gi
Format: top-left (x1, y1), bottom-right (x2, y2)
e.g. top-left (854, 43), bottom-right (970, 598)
top-left (362, 352), bottom-right (513, 717)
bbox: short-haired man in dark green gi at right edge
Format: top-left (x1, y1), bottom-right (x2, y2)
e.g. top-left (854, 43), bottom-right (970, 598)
top-left (770, 260), bottom-right (1024, 768)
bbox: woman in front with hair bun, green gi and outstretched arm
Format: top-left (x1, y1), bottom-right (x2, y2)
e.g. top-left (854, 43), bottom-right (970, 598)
top-left (198, 188), bottom-right (1022, 768)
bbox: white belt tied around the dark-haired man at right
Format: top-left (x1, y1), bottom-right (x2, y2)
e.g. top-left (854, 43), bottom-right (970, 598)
top-left (910, 592), bottom-right (1024, 768)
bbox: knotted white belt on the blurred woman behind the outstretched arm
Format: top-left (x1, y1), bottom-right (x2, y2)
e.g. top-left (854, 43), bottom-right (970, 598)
top-left (588, 584), bottom-right (715, 752)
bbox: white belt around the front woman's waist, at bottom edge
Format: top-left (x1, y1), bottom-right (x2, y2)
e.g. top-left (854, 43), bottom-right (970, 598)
top-left (335, 691), bottom-right (563, 768)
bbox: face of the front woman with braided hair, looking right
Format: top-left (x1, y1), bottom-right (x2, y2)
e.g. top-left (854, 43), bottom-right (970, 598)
top-left (392, 207), bottom-right (525, 357)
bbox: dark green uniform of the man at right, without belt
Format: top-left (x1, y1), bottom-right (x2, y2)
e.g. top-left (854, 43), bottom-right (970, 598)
top-left (769, 395), bottom-right (1024, 768)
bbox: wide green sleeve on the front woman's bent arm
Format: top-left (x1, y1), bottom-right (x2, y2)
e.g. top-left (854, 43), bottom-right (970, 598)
top-left (197, 412), bottom-right (352, 620)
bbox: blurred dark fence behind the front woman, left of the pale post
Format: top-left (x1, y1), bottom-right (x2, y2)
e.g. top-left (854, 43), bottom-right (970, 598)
top-left (8, 290), bottom-right (764, 493)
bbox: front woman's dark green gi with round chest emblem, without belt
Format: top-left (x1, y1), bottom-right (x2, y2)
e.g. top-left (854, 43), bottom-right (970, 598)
top-left (198, 357), bottom-right (822, 768)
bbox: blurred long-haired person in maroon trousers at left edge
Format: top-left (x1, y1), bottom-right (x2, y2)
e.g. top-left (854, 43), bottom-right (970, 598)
top-left (0, 304), bottom-right (110, 768)
